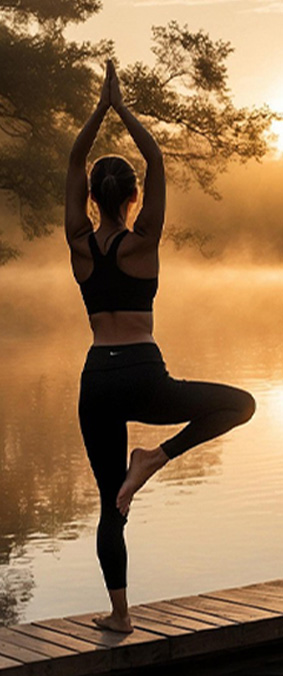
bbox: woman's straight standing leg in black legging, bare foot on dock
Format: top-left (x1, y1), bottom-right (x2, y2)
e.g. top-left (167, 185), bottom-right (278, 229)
top-left (79, 373), bottom-right (132, 633)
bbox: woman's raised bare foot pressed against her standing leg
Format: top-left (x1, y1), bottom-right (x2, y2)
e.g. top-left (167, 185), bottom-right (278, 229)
top-left (116, 446), bottom-right (169, 516)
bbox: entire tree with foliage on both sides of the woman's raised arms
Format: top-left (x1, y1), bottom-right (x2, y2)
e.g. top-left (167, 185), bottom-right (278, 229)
top-left (0, 9), bottom-right (274, 262)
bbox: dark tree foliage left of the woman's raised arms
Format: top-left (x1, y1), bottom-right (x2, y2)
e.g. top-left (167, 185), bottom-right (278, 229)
top-left (0, 0), bottom-right (113, 263)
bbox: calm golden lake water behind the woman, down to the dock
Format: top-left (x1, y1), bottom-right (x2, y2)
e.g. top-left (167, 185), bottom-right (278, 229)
top-left (0, 263), bottom-right (283, 624)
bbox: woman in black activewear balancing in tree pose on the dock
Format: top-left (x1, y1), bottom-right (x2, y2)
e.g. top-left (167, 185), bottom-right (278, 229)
top-left (66, 61), bottom-right (255, 633)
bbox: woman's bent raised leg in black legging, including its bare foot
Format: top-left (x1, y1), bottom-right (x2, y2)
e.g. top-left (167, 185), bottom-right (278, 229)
top-left (116, 369), bottom-right (255, 514)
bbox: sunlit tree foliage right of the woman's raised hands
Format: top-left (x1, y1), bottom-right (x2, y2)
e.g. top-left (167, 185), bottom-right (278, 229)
top-left (122, 21), bottom-right (273, 198)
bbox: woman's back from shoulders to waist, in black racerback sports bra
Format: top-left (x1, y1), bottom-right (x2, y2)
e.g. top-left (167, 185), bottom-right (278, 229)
top-left (72, 226), bottom-right (159, 345)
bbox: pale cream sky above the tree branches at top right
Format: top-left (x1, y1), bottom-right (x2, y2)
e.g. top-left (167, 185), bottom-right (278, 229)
top-left (66, 0), bottom-right (283, 111)
